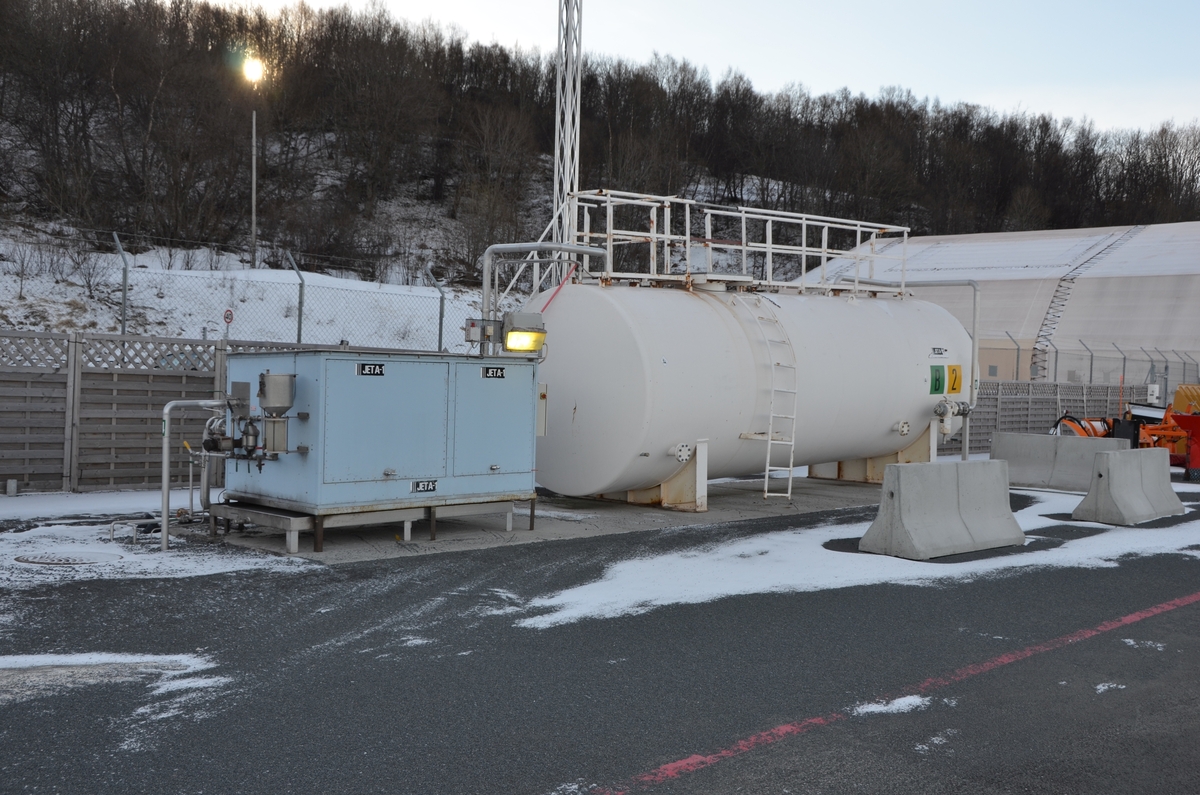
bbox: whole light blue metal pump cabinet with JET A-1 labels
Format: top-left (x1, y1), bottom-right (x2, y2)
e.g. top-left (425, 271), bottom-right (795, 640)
top-left (222, 349), bottom-right (539, 516)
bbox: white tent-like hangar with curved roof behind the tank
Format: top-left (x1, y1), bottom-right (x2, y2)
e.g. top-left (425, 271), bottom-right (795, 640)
top-left (805, 222), bottom-right (1200, 395)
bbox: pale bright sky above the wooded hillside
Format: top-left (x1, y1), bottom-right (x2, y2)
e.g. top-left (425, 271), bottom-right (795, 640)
top-left (248, 0), bottom-right (1200, 128)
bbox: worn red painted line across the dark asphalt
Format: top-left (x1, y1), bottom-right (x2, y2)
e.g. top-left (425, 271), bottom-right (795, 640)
top-left (587, 591), bottom-right (1200, 795)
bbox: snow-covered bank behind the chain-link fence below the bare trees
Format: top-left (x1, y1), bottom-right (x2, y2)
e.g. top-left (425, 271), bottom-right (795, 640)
top-left (0, 240), bottom-right (492, 352)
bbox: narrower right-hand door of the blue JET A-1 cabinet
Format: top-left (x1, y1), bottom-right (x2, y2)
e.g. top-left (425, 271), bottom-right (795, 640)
top-left (454, 360), bottom-right (538, 476)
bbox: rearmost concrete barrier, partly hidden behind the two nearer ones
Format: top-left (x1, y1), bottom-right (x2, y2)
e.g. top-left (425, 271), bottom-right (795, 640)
top-left (991, 434), bottom-right (1129, 492)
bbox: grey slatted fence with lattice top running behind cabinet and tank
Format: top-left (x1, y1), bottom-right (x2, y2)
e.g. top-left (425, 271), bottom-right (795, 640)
top-left (0, 331), bottom-right (1161, 491)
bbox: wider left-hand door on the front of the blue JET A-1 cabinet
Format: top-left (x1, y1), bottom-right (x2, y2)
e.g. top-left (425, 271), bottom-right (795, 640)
top-left (324, 359), bottom-right (450, 483)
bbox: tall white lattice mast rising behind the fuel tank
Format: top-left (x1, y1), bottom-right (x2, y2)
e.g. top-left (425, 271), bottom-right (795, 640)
top-left (553, 0), bottom-right (583, 243)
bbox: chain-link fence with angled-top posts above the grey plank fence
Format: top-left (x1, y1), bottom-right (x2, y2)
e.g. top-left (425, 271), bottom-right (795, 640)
top-left (0, 234), bottom-right (481, 352)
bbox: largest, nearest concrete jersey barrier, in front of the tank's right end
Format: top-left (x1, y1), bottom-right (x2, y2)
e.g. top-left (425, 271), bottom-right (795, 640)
top-left (858, 461), bottom-right (1025, 561)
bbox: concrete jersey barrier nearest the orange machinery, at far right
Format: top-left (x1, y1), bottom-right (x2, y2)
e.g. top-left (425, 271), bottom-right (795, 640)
top-left (1070, 447), bottom-right (1184, 526)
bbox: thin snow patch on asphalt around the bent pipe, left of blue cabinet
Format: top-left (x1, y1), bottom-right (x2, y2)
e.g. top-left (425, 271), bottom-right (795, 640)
top-left (0, 521), bottom-right (318, 588)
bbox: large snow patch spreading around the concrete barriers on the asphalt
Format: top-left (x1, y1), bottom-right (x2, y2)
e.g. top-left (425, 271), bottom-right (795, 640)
top-left (516, 491), bottom-right (1200, 629)
